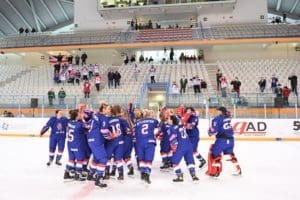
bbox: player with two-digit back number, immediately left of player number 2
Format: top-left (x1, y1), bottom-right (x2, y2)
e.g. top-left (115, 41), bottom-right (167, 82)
top-left (103, 106), bottom-right (128, 180)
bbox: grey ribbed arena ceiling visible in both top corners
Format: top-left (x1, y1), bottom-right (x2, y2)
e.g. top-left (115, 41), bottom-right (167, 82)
top-left (0, 0), bottom-right (300, 36)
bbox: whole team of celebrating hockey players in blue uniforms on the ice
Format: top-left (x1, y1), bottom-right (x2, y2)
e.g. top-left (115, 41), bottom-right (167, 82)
top-left (40, 103), bottom-right (241, 187)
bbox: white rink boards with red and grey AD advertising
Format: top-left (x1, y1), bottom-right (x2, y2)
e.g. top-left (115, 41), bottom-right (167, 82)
top-left (0, 118), bottom-right (300, 141)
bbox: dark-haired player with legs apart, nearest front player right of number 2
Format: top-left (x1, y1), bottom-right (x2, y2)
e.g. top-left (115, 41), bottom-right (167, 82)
top-left (168, 115), bottom-right (199, 182)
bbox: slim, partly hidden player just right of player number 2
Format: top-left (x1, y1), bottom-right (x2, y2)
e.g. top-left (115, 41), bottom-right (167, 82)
top-left (157, 112), bottom-right (173, 169)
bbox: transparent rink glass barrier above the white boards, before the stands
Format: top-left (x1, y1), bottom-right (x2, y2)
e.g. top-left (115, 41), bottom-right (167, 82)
top-left (0, 94), bottom-right (300, 119)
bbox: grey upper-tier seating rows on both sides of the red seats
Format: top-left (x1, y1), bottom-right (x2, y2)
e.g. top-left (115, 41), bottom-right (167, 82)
top-left (0, 24), bottom-right (300, 48)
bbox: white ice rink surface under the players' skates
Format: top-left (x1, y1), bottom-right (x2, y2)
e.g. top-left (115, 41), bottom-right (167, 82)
top-left (0, 137), bottom-right (300, 200)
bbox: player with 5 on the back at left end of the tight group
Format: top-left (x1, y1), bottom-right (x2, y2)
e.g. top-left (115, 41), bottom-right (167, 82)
top-left (64, 110), bottom-right (86, 181)
